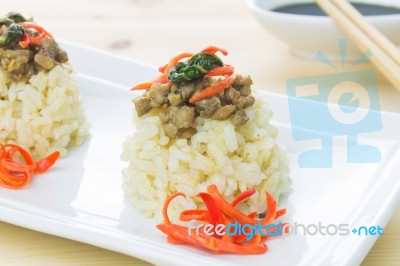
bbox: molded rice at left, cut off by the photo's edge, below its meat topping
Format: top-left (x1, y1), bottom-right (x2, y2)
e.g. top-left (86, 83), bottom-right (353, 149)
top-left (0, 63), bottom-right (88, 160)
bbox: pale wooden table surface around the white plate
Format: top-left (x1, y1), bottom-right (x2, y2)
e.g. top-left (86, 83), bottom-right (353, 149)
top-left (0, 0), bottom-right (400, 266)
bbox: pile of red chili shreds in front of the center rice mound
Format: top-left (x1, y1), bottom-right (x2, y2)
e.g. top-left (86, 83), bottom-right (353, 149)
top-left (157, 185), bottom-right (286, 255)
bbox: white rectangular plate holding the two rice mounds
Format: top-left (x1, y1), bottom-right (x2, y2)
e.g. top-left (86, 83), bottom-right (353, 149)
top-left (0, 42), bottom-right (400, 265)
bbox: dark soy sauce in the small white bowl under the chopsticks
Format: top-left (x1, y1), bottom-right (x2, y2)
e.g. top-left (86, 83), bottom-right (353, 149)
top-left (272, 3), bottom-right (400, 16)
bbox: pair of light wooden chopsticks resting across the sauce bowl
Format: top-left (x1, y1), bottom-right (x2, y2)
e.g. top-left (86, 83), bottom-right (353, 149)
top-left (316, 0), bottom-right (400, 90)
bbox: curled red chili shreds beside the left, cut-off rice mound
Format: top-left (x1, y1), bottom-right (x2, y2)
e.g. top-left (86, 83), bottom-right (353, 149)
top-left (0, 144), bottom-right (60, 189)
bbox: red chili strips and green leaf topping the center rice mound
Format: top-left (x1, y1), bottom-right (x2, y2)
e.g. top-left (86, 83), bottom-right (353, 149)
top-left (131, 46), bottom-right (235, 103)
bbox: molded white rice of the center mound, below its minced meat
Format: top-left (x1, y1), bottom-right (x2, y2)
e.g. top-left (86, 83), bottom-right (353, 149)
top-left (121, 99), bottom-right (289, 221)
